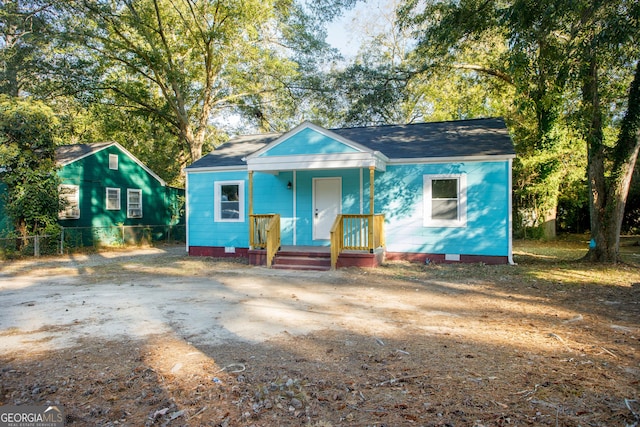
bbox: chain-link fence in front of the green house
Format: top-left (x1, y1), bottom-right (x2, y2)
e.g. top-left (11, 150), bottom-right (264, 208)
top-left (0, 225), bottom-right (186, 258)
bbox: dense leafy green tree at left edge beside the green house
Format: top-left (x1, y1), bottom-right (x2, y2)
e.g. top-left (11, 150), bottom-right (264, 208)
top-left (0, 96), bottom-right (62, 235)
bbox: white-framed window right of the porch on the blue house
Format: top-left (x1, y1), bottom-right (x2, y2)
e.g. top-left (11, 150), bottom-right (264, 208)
top-left (424, 174), bottom-right (467, 227)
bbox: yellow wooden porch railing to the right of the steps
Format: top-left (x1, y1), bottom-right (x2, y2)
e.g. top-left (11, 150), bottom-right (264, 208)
top-left (331, 214), bottom-right (385, 270)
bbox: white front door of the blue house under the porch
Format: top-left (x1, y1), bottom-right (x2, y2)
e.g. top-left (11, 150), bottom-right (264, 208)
top-left (313, 177), bottom-right (342, 240)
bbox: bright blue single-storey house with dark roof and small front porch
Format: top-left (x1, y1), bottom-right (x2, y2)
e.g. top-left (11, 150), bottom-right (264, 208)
top-left (186, 119), bottom-right (515, 268)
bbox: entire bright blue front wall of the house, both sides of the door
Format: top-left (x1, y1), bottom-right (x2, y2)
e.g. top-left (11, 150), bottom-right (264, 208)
top-left (187, 161), bottom-right (510, 256)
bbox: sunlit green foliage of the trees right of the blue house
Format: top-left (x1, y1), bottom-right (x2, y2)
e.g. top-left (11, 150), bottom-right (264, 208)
top-left (398, 0), bottom-right (640, 247)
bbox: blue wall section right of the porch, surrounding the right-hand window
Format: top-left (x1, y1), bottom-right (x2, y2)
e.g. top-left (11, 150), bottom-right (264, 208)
top-left (376, 161), bottom-right (510, 256)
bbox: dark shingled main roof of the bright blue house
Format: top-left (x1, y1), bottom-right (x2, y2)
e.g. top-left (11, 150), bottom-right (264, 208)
top-left (187, 118), bottom-right (515, 169)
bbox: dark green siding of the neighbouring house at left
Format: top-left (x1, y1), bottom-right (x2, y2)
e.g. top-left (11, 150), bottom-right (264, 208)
top-left (58, 145), bottom-right (184, 231)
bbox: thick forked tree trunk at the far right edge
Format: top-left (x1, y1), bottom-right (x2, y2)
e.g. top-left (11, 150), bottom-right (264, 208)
top-left (583, 57), bottom-right (640, 263)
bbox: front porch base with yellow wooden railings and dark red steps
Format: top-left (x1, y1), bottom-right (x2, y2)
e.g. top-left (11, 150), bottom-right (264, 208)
top-left (248, 214), bottom-right (385, 270)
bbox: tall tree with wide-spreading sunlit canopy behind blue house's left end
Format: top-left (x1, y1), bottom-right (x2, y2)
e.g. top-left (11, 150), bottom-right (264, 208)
top-left (61, 0), bottom-right (324, 163)
